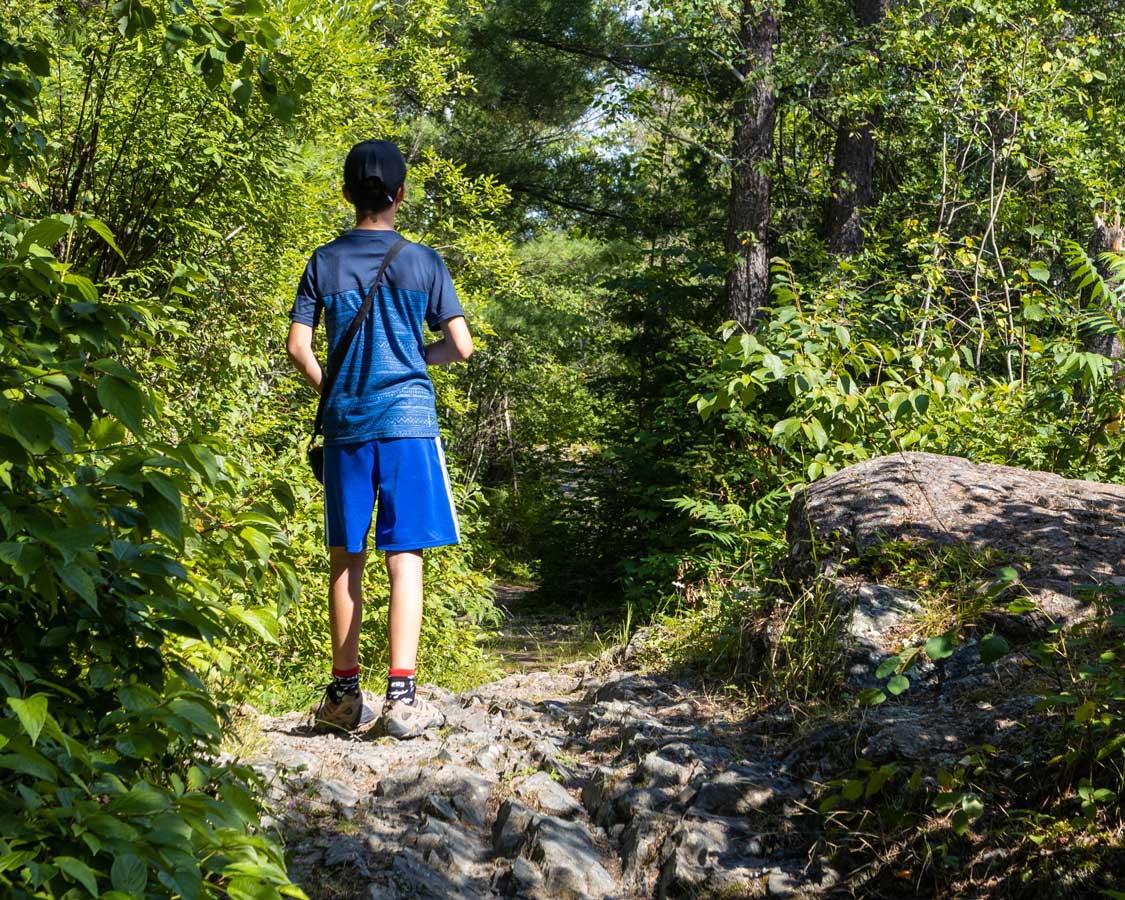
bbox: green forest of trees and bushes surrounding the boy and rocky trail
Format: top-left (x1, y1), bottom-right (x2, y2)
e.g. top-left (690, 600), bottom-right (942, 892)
top-left (0, 0), bottom-right (1125, 900)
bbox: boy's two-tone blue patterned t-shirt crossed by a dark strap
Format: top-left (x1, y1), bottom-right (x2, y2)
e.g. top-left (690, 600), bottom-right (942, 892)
top-left (289, 228), bottom-right (465, 443)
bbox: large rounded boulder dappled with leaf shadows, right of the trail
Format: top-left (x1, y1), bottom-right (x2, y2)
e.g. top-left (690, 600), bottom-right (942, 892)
top-left (786, 452), bottom-right (1125, 596)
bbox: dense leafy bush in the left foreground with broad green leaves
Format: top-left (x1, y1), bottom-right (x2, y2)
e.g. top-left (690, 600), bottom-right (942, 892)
top-left (0, 216), bottom-right (300, 898)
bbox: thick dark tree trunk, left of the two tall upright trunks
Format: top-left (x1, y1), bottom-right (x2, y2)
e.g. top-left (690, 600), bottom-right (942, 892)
top-left (727, 0), bottom-right (781, 329)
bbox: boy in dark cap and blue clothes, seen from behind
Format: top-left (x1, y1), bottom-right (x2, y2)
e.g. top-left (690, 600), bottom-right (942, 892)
top-left (287, 141), bottom-right (473, 738)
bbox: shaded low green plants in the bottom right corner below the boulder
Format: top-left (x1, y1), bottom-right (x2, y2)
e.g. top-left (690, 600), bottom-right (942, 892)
top-left (820, 591), bottom-right (1125, 896)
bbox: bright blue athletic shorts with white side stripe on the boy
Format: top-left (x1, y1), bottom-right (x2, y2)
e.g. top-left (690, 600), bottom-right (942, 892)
top-left (324, 438), bottom-right (460, 554)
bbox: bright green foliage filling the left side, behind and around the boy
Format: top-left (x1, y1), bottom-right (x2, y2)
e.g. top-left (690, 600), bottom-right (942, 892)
top-left (0, 2), bottom-right (524, 898)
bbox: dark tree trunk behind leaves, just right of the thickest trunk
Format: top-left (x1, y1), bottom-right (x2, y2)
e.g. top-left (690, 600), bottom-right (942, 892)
top-left (825, 0), bottom-right (891, 257)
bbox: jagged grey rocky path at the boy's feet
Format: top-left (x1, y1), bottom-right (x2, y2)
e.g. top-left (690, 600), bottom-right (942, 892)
top-left (248, 634), bottom-right (834, 900)
